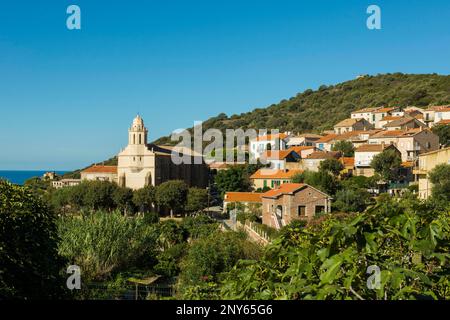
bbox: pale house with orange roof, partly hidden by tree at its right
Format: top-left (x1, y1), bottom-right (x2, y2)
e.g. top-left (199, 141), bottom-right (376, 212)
top-left (354, 143), bottom-right (400, 177)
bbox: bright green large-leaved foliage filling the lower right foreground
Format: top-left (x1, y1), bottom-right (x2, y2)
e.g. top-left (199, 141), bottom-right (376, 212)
top-left (220, 199), bottom-right (450, 300)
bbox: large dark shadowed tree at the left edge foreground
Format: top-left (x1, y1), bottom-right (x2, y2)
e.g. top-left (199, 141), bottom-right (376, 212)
top-left (0, 180), bottom-right (65, 299)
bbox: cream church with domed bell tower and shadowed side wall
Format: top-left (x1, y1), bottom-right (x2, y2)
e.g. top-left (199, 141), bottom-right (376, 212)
top-left (117, 115), bottom-right (209, 190)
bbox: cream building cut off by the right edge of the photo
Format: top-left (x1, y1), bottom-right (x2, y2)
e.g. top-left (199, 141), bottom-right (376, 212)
top-left (413, 147), bottom-right (450, 199)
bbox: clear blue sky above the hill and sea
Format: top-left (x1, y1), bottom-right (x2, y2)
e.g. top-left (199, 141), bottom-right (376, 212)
top-left (0, 0), bottom-right (450, 170)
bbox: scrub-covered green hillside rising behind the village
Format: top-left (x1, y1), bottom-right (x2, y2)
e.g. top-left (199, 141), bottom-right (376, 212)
top-left (154, 73), bottom-right (450, 144)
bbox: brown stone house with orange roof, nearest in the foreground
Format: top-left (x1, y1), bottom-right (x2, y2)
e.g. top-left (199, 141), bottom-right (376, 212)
top-left (262, 183), bottom-right (331, 229)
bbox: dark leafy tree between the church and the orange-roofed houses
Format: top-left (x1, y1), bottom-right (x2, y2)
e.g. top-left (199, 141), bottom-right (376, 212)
top-left (214, 166), bottom-right (250, 198)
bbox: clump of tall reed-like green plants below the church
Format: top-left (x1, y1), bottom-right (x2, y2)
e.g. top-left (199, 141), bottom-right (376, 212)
top-left (58, 211), bottom-right (158, 281)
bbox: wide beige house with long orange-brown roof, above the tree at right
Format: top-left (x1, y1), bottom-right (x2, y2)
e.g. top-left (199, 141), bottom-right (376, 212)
top-left (369, 127), bottom-right (439, 161)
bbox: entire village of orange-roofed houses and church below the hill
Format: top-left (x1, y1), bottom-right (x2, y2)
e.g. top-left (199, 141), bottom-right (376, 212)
top-left (39, 106), bottom-right (450, 241)
